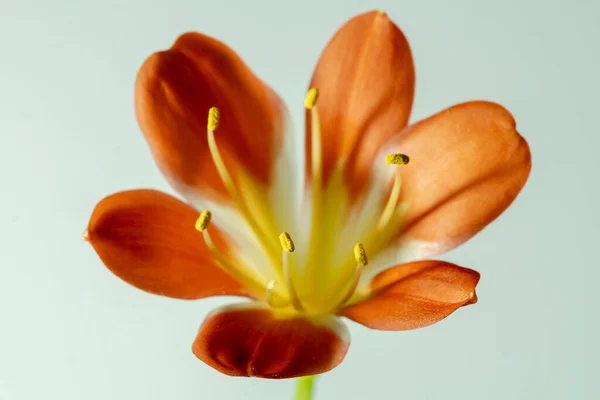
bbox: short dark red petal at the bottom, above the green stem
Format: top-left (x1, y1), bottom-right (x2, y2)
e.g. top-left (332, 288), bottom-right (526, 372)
top-left (192, 303), bottom-right (350, 378)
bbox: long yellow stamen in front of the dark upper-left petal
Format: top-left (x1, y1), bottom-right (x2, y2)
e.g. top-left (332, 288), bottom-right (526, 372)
top-left (207, 107), bottom-right (279, 276)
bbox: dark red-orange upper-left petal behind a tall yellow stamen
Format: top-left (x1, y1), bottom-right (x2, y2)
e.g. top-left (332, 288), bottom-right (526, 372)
top-left (135, 33), bottom-right (286, 200)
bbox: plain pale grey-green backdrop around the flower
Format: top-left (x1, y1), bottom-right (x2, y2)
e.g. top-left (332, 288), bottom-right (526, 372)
top-left (0, 0), bottom-right (600, 400)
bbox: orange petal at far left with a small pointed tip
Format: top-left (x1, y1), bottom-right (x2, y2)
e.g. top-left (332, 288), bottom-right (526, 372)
top-left (85, 190), bottom-right (248, 299)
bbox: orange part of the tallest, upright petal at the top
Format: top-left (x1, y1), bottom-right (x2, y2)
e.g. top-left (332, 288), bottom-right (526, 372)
top-left (306, 11), bottom-right (415, 193)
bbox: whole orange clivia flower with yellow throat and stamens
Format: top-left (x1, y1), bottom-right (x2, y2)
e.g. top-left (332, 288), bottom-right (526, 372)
top-left (85, 11), bottom-right (531, 378)
